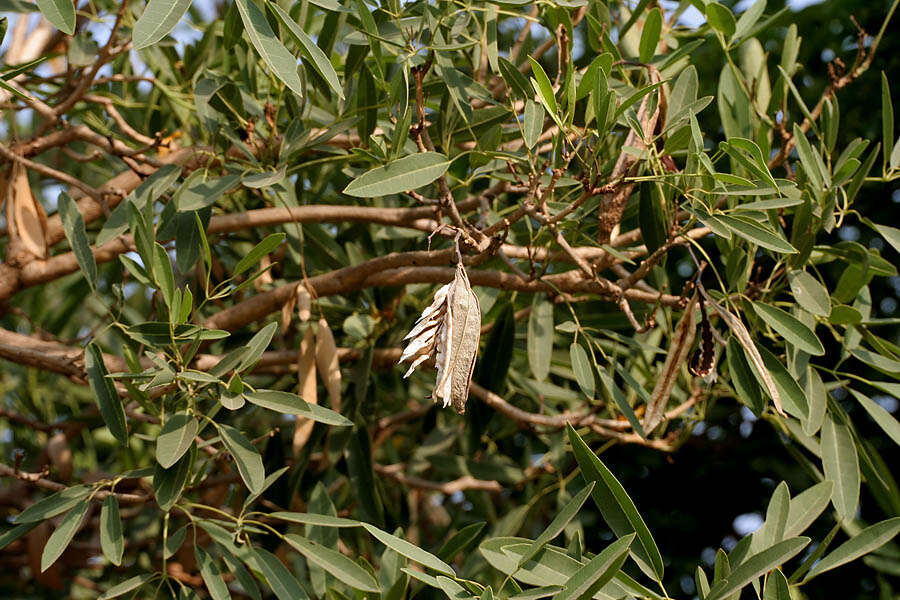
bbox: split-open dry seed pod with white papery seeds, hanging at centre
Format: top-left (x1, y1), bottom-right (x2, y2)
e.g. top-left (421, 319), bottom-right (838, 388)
top-left (398, 263), bottom-right (481, 414)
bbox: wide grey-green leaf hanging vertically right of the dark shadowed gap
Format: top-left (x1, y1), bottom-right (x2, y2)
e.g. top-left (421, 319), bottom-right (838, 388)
top-left (822, 415), bottom-right (860, 521)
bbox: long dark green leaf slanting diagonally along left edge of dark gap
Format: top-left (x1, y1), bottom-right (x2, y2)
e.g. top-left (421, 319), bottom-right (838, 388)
top-left (566, 425), bottom-right (663, 581)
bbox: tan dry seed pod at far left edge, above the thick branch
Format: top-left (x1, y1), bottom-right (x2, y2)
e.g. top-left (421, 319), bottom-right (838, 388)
top-left (6, 162), bottom-right (47, 262)
